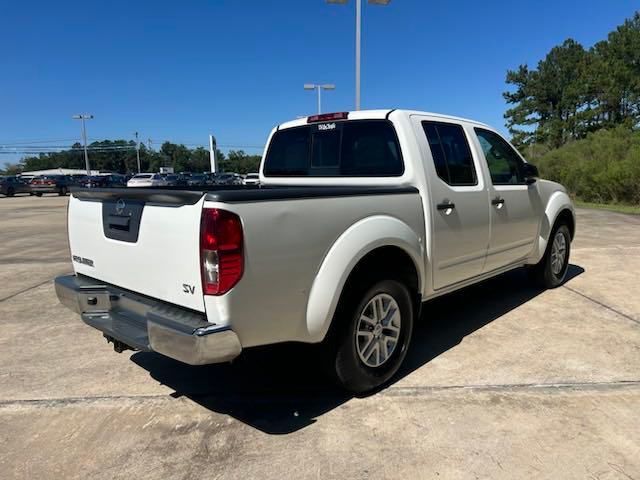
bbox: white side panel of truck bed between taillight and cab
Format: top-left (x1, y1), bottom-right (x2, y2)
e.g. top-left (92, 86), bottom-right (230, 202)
top-left (205, 193), bottom-right (424, 347)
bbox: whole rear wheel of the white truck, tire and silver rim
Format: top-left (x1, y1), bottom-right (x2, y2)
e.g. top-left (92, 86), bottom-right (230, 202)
top-left (332, 280), bottom-right (414, 393)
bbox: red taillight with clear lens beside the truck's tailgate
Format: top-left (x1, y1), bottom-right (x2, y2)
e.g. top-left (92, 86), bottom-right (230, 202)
top-left (200, 208), bottom-right (244, 295)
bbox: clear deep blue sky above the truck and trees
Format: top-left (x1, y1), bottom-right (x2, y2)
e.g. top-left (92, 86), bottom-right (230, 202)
top-left (0, 0), bottom-right (640, 164)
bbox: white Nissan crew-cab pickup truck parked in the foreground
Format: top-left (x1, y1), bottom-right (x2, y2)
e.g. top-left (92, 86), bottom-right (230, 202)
top-left (55, 110), bottom-right (575, 392)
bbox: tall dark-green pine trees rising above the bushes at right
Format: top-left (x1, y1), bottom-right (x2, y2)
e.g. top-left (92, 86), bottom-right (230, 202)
top-left (503, 12), bottom-right (640, 148)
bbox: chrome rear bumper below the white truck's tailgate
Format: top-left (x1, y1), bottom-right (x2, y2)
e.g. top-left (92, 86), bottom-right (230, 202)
top-left (55, 275), bottom-right (242, 365)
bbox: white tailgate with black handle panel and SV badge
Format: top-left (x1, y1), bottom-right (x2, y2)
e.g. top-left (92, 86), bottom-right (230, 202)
top-left (68, 188), bottom-right (204, 312)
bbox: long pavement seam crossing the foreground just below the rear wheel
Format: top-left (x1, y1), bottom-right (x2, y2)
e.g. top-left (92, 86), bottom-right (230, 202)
top-left (0, 380), bottom-right (640, 410)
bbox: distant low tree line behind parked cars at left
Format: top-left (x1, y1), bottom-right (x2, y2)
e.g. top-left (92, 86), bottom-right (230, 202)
top-left (6, 140), bottom-right (261, 174)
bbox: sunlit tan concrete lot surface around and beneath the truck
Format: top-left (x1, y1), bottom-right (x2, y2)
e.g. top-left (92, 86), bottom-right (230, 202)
top-left (0, 197), bottom-right (640, 479)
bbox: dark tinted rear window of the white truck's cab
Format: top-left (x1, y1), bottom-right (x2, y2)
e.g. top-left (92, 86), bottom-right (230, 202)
top-left (263, 120), bottom-right (404, 177)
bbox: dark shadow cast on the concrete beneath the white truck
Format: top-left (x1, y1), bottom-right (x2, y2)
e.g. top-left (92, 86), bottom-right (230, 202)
top-left (131, 265), bottom-right (584, 434)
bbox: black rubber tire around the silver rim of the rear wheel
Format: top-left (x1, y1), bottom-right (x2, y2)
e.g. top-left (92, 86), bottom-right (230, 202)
top-left (328, 280), bottom-right (415, 393)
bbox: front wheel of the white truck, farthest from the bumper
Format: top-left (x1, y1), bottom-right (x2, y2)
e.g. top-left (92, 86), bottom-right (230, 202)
top-left (531, 224), bottom-right (571, 288)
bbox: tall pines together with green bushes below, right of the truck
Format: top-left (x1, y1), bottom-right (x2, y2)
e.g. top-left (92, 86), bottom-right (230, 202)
top-left (504, 12), bottom-right (640, 205)
